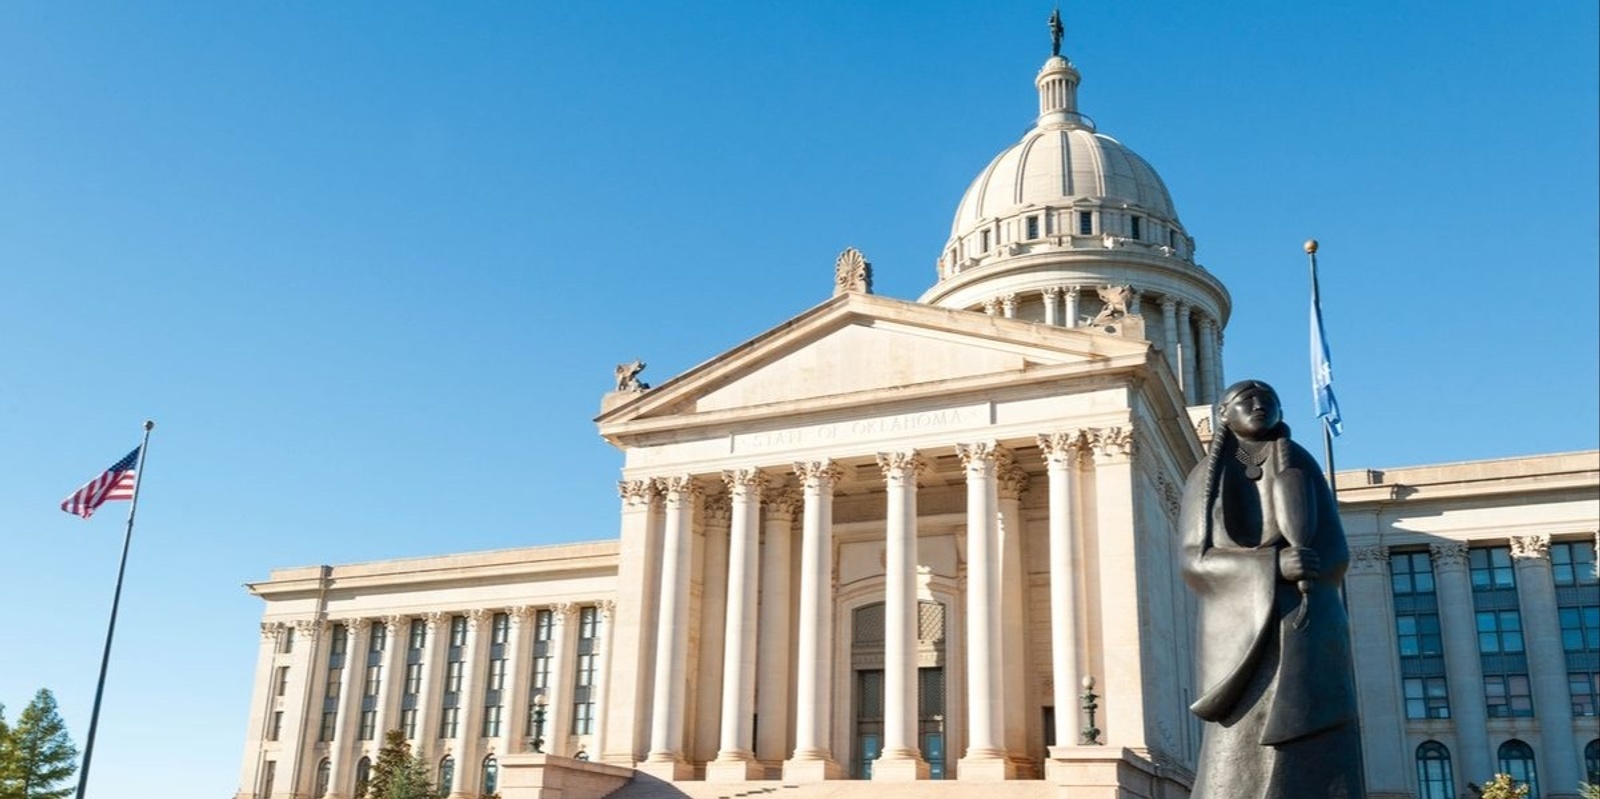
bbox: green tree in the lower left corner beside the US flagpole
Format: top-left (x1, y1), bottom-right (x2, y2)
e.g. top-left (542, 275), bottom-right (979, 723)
top-left (0, 689), bottom-right (78, 799)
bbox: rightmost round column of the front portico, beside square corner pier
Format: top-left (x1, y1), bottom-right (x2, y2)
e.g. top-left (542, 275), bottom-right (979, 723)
top-left (1038, 431), bottom-right (1088, 757)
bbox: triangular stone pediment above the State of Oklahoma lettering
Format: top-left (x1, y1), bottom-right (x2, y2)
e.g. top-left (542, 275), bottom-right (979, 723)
top-left (595, 295), bottom-right (1149, 437)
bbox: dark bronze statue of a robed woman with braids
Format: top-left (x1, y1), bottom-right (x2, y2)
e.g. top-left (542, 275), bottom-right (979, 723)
top-left (1179, 379), bottom-right (1366, 799)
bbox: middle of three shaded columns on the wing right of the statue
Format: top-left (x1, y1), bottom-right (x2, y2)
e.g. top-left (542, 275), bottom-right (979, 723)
top-left (1429, 541), bottom-right (1494, 775)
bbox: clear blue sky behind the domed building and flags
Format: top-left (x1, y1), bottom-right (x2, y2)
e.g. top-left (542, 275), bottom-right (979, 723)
top-left (0, 0), bottom-right (1600, 799)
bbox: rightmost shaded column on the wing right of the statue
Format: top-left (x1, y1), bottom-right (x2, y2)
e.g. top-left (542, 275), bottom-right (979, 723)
top-left (1510, 535), bottom-right (1594, 796)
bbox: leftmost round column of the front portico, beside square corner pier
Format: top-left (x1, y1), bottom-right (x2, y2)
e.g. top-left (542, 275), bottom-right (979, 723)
top-left (638, 476), bottom-right (701, 780)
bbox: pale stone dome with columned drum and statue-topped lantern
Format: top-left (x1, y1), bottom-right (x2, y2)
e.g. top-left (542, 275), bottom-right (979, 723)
top-left (918, 14), bottom-right (1232, 405)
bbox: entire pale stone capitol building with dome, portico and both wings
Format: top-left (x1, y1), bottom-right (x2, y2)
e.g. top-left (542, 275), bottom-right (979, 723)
top-left (237, 23), bottom-right (1600, 799)
